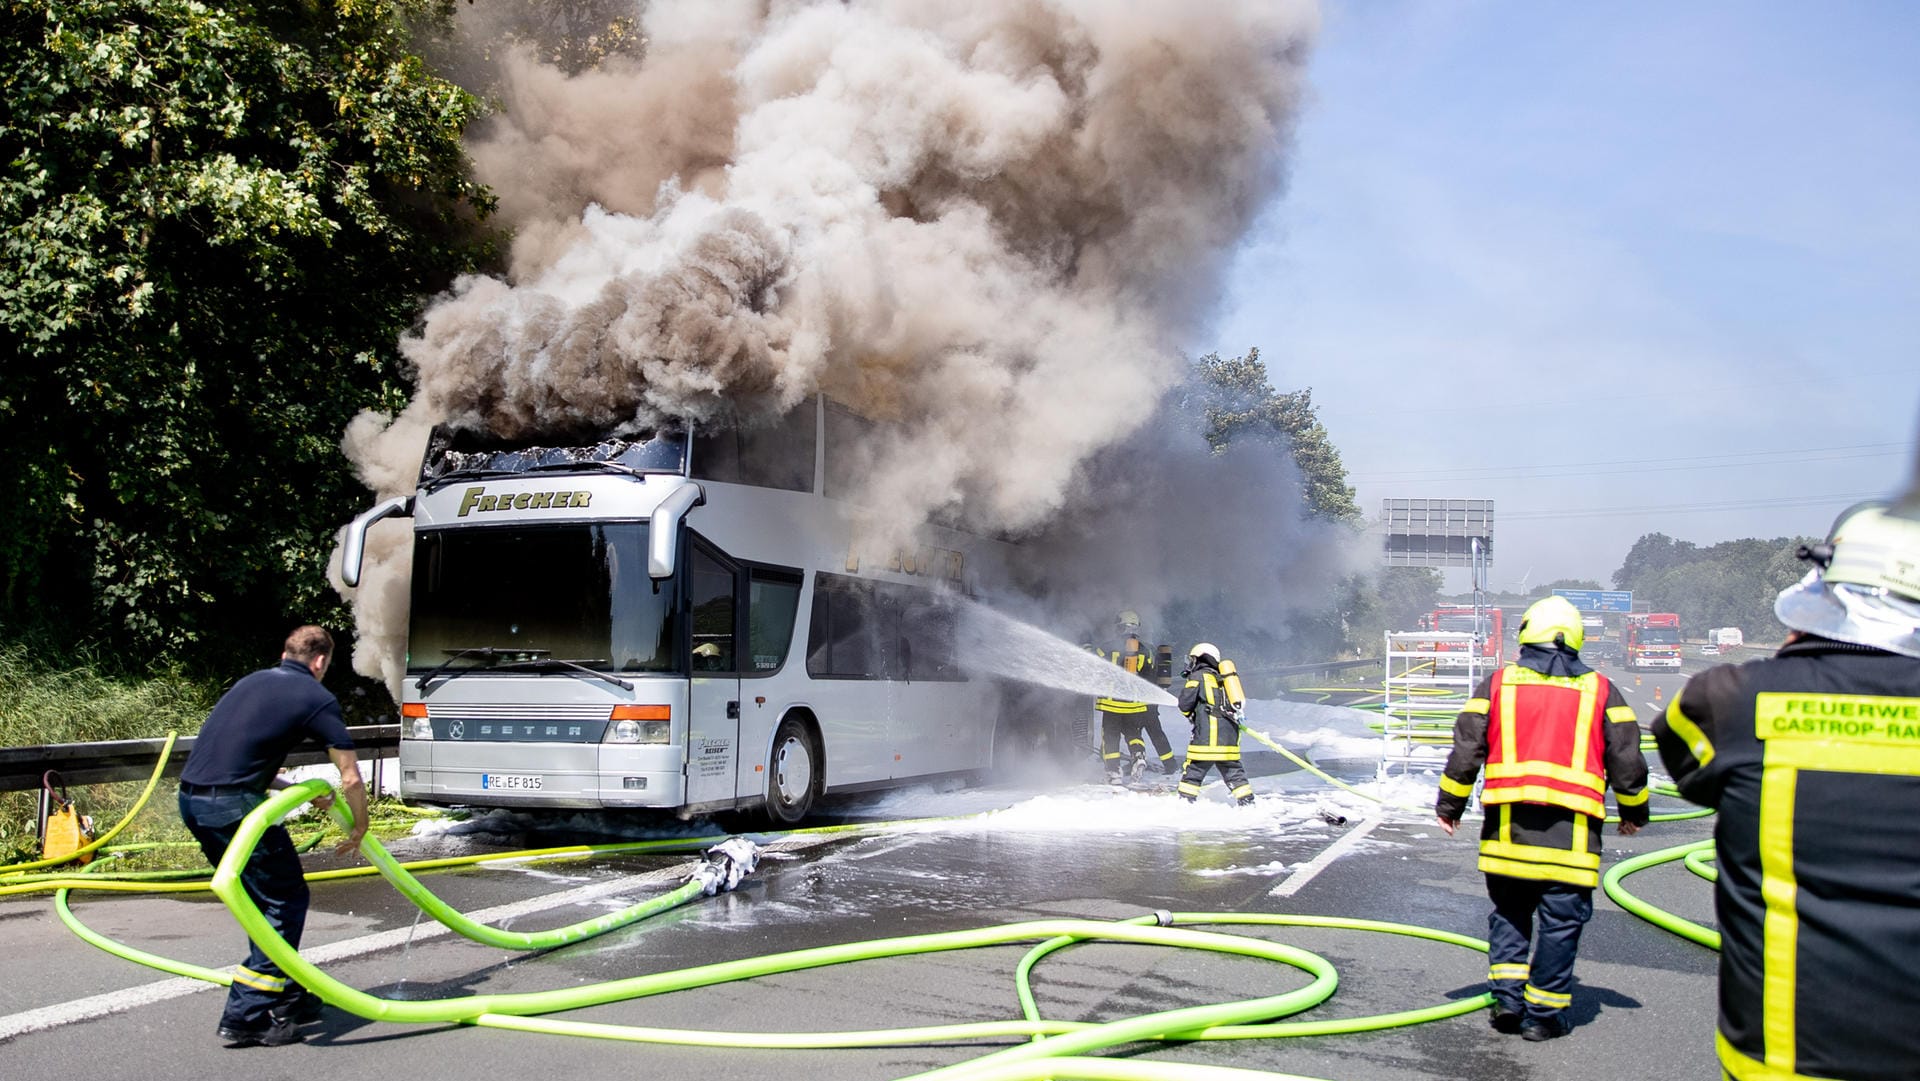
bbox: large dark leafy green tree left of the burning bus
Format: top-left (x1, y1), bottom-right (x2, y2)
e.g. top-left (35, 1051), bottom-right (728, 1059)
top-left (0, 0), bottom-right (490, 668)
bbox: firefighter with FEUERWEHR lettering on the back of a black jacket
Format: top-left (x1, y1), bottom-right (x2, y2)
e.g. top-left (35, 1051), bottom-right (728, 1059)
top-left (1653, 503), bottom-right (1920, 1081)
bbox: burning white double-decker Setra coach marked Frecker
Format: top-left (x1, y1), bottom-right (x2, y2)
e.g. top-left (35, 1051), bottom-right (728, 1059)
top-left (342, 397), bottom-right (1044, 824)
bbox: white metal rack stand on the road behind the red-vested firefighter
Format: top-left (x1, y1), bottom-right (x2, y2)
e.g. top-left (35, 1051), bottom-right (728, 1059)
top-left (1377, 630), bottom-right (1482, 781)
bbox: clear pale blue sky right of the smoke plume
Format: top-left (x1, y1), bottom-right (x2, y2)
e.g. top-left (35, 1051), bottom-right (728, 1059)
top-left (1198, 0), bottom-right (1920, 588)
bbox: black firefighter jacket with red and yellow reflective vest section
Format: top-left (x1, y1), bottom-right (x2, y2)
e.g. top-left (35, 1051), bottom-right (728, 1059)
top-left (1434, 647), bottom-right (1647, 887)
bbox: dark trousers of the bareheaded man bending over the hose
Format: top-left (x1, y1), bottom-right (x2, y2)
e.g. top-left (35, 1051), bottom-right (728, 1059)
top-left (180, 787), bottom-right (309, 1031)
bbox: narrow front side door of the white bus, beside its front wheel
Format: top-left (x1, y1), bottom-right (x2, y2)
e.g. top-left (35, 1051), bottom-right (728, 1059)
top-left (687, 543), bottom-right (741, 803)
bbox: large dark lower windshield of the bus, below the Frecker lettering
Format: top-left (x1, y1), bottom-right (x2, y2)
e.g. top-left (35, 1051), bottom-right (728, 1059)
top-left (407, 522), bottom-right (680, 672)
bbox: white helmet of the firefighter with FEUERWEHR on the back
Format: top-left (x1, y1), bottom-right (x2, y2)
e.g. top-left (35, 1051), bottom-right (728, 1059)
top-left (1774, 501), bottom-right (1920, 657)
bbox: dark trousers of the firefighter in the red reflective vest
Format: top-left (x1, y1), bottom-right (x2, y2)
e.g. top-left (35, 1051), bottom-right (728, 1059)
top-left (1486, 874), bottom-right (1594, 1021)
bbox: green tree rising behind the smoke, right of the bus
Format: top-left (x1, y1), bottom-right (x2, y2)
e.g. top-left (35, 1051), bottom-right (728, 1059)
top-left (1194, 348), bottom-right (1359, 522)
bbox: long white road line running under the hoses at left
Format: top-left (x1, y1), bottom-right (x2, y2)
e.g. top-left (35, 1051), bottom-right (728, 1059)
top-left (0, 837), bottom-right (826, 1043)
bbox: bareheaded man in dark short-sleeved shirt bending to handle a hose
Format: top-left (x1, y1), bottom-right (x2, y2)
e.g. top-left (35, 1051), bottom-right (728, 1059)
top-left (180, 626), bottom-right (367, 1046)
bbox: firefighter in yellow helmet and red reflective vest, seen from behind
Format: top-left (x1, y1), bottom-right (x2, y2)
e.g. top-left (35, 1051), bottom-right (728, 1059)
top-left (1434, 597), bottom-right (1647, 1041)
